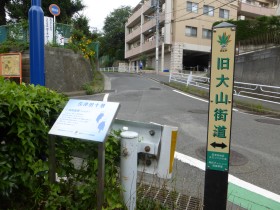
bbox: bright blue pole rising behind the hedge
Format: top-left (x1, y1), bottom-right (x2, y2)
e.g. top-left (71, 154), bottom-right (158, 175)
top-left (28, 0), bottom-right (45, 86)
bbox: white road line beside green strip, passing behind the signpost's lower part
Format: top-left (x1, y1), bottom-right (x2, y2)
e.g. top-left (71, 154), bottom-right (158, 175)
top-left (175, 152), bottom-right (280, 202)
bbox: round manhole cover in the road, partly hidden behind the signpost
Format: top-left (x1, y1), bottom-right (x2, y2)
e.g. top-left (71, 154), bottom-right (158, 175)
top-left (195, 147), bottom-right (248, 166)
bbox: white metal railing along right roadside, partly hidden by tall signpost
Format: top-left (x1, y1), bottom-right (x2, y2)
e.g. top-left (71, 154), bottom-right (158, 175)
top-left (169, 72), bottom-right (280, 105)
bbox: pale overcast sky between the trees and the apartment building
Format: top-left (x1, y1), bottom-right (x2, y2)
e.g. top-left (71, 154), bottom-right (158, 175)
top-left (83, 0), bottom-right (140, 31)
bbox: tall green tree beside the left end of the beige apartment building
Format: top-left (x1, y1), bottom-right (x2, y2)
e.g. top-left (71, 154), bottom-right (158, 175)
top-left (100, 6), bottom-right (131, 63)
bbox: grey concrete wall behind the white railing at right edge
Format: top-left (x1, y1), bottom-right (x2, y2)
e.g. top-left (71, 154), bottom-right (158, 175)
top-left (234, 47), bottom-right (280, 86)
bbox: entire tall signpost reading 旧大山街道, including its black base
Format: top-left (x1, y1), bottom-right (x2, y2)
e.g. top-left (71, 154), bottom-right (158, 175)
top-left (204, 22), bottom-right (236, 210)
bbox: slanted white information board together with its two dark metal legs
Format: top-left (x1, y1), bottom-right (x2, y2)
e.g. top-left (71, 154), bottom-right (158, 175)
top-left (49, 99), bottom-right (119, 210)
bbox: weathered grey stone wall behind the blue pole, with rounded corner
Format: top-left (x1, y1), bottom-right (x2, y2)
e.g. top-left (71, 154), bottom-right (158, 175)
top-left (22, 47), bottom-right (93, 92)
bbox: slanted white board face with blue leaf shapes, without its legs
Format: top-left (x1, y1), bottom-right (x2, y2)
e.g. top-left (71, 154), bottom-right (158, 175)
top-left (49, 99), bottom-right (120, 142)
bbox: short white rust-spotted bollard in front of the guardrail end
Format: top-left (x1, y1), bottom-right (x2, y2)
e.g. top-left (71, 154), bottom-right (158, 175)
top-left (121, 131), bottom-right (138, 210)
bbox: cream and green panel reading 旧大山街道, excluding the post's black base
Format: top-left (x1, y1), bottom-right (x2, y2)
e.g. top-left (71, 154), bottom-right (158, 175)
top-left (206, 23), bottom-right (236, 172)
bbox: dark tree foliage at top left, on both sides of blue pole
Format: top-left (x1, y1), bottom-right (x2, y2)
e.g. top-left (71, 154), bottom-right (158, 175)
top-left (6, 0), bottom-right (85, 23)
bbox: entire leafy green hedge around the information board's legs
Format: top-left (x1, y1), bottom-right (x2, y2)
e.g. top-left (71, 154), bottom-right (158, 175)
top-left (0, 78), bottom-right (122, 209)
